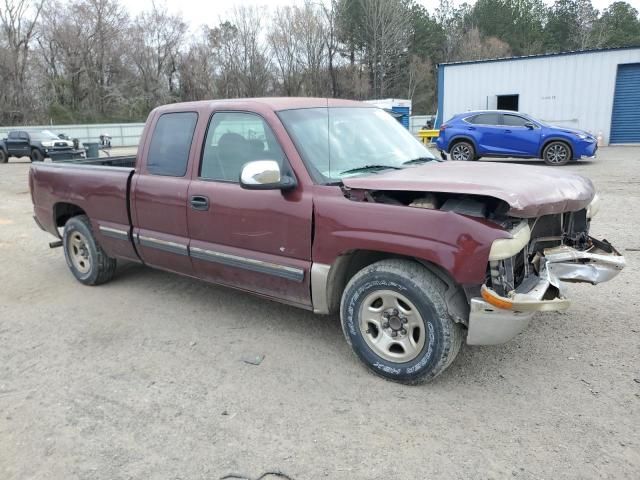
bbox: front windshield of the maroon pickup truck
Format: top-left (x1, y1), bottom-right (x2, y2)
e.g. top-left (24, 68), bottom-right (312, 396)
top-left (278, 107), bottom-right (436, 183)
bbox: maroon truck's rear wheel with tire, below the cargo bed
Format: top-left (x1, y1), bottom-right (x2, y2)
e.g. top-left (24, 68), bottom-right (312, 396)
top-left (62, 215), bottom-right (117, 285)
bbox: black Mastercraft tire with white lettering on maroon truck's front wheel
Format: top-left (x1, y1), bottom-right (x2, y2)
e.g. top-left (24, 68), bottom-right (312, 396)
top-left (340, 259), bottom-right (463, 383)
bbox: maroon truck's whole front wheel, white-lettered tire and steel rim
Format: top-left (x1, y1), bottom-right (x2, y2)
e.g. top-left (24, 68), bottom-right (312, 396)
top-left (340, 260), bottom-right (463, 383)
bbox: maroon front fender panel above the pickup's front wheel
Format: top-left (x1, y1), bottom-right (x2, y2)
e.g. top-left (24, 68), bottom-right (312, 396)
top-left (312, 186), bottom-right (510, 285)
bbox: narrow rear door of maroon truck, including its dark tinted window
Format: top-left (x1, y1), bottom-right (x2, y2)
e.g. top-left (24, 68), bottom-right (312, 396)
top-left (132, 111), bottom-right (198, 275)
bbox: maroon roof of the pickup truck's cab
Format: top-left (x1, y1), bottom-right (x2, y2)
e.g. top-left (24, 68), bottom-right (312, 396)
top-left (152, 97), bottom-right (368, 112)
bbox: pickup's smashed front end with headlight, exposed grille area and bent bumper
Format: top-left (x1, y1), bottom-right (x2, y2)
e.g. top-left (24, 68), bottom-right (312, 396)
top-left (467, 202), bottom-right (625, 345)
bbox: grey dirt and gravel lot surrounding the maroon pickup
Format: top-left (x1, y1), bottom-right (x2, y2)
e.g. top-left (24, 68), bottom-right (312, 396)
top-left (0, 147), bottom-right (640, 480)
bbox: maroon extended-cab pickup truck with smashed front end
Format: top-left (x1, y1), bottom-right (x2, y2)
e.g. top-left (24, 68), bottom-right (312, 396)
top-left (29, 98), bottom-right (624, 383)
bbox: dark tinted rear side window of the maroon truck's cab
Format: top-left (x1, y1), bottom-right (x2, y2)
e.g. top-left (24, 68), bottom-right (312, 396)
top-left (147, 112), bottom-right (198, 177)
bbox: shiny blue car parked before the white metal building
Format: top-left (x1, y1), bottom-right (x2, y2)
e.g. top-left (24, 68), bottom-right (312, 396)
top-left (436, 110), bottom-right (598, 165)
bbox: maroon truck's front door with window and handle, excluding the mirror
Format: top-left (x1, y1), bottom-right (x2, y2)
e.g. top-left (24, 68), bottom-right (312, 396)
top-left (188, 112), bottom-right (312, 306)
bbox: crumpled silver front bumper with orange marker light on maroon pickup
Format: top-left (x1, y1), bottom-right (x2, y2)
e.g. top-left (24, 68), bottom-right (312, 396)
top-left (467, 241), bottom-right (625, 345)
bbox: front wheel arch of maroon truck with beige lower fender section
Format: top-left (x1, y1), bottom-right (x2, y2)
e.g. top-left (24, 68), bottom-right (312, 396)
top-left (311, 250), bottom-right (469, 324)
